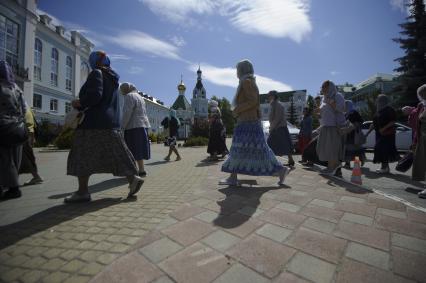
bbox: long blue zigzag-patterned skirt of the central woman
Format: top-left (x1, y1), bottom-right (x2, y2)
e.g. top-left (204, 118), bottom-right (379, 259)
top-left (222, 121), bottom-right (283, 176)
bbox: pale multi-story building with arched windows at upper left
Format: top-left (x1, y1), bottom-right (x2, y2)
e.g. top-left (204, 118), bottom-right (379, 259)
top-left (0, 0), bottom-right (93, 124)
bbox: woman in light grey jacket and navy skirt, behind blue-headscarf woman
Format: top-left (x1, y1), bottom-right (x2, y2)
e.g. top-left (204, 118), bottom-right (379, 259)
top-left (120, 83), bottom-right (151, 177)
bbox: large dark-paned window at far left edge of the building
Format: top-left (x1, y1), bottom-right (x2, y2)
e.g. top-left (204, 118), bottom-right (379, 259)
top-left (0, 15), bottom-right (19, 68)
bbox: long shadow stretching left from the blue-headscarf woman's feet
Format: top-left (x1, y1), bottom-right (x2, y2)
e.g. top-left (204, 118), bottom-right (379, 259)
top-left (0, 198), bottom-right (121, 250)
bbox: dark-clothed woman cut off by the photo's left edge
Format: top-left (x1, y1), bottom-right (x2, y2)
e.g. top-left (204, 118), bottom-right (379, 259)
top-left (0, 60), bottom-right (26, 199)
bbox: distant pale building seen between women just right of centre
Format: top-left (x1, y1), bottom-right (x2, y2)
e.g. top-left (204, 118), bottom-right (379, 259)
top-left (260, 90), bottom-right (306, 123)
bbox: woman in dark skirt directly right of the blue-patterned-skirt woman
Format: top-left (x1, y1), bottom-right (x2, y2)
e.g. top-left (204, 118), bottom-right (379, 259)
top-left (268, 90), bottom-right (294, 167)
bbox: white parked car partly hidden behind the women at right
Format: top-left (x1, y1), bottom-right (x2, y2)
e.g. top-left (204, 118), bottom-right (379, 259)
top-left (362, 121), bottom-right (412, 150)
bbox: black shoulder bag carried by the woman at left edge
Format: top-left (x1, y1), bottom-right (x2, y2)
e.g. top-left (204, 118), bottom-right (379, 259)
top-left (0, 94), bottom-right (29, 147)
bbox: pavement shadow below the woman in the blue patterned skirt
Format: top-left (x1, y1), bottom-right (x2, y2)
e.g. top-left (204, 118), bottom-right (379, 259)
top-left (213, 185), bottom-right (290, 229)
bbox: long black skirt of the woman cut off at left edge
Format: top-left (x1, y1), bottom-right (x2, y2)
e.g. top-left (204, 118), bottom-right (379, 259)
top-left (0, 145), bottom-right (22, 188)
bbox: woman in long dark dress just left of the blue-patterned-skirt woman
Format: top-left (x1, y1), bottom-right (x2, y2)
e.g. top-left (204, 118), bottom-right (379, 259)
top-left (207, 102), bottom-right (228, 160)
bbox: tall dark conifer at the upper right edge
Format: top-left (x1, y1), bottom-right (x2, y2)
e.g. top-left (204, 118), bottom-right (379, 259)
top-left (393, 0), bottom-right (426, 105)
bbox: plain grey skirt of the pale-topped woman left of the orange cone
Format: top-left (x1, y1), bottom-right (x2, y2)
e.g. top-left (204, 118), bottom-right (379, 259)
top-left (317, 126), bottom-right (345, 161)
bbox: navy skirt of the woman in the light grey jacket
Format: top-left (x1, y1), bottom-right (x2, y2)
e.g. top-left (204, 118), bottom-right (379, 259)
top-left (124, 128), bottom-right (151, 160)
